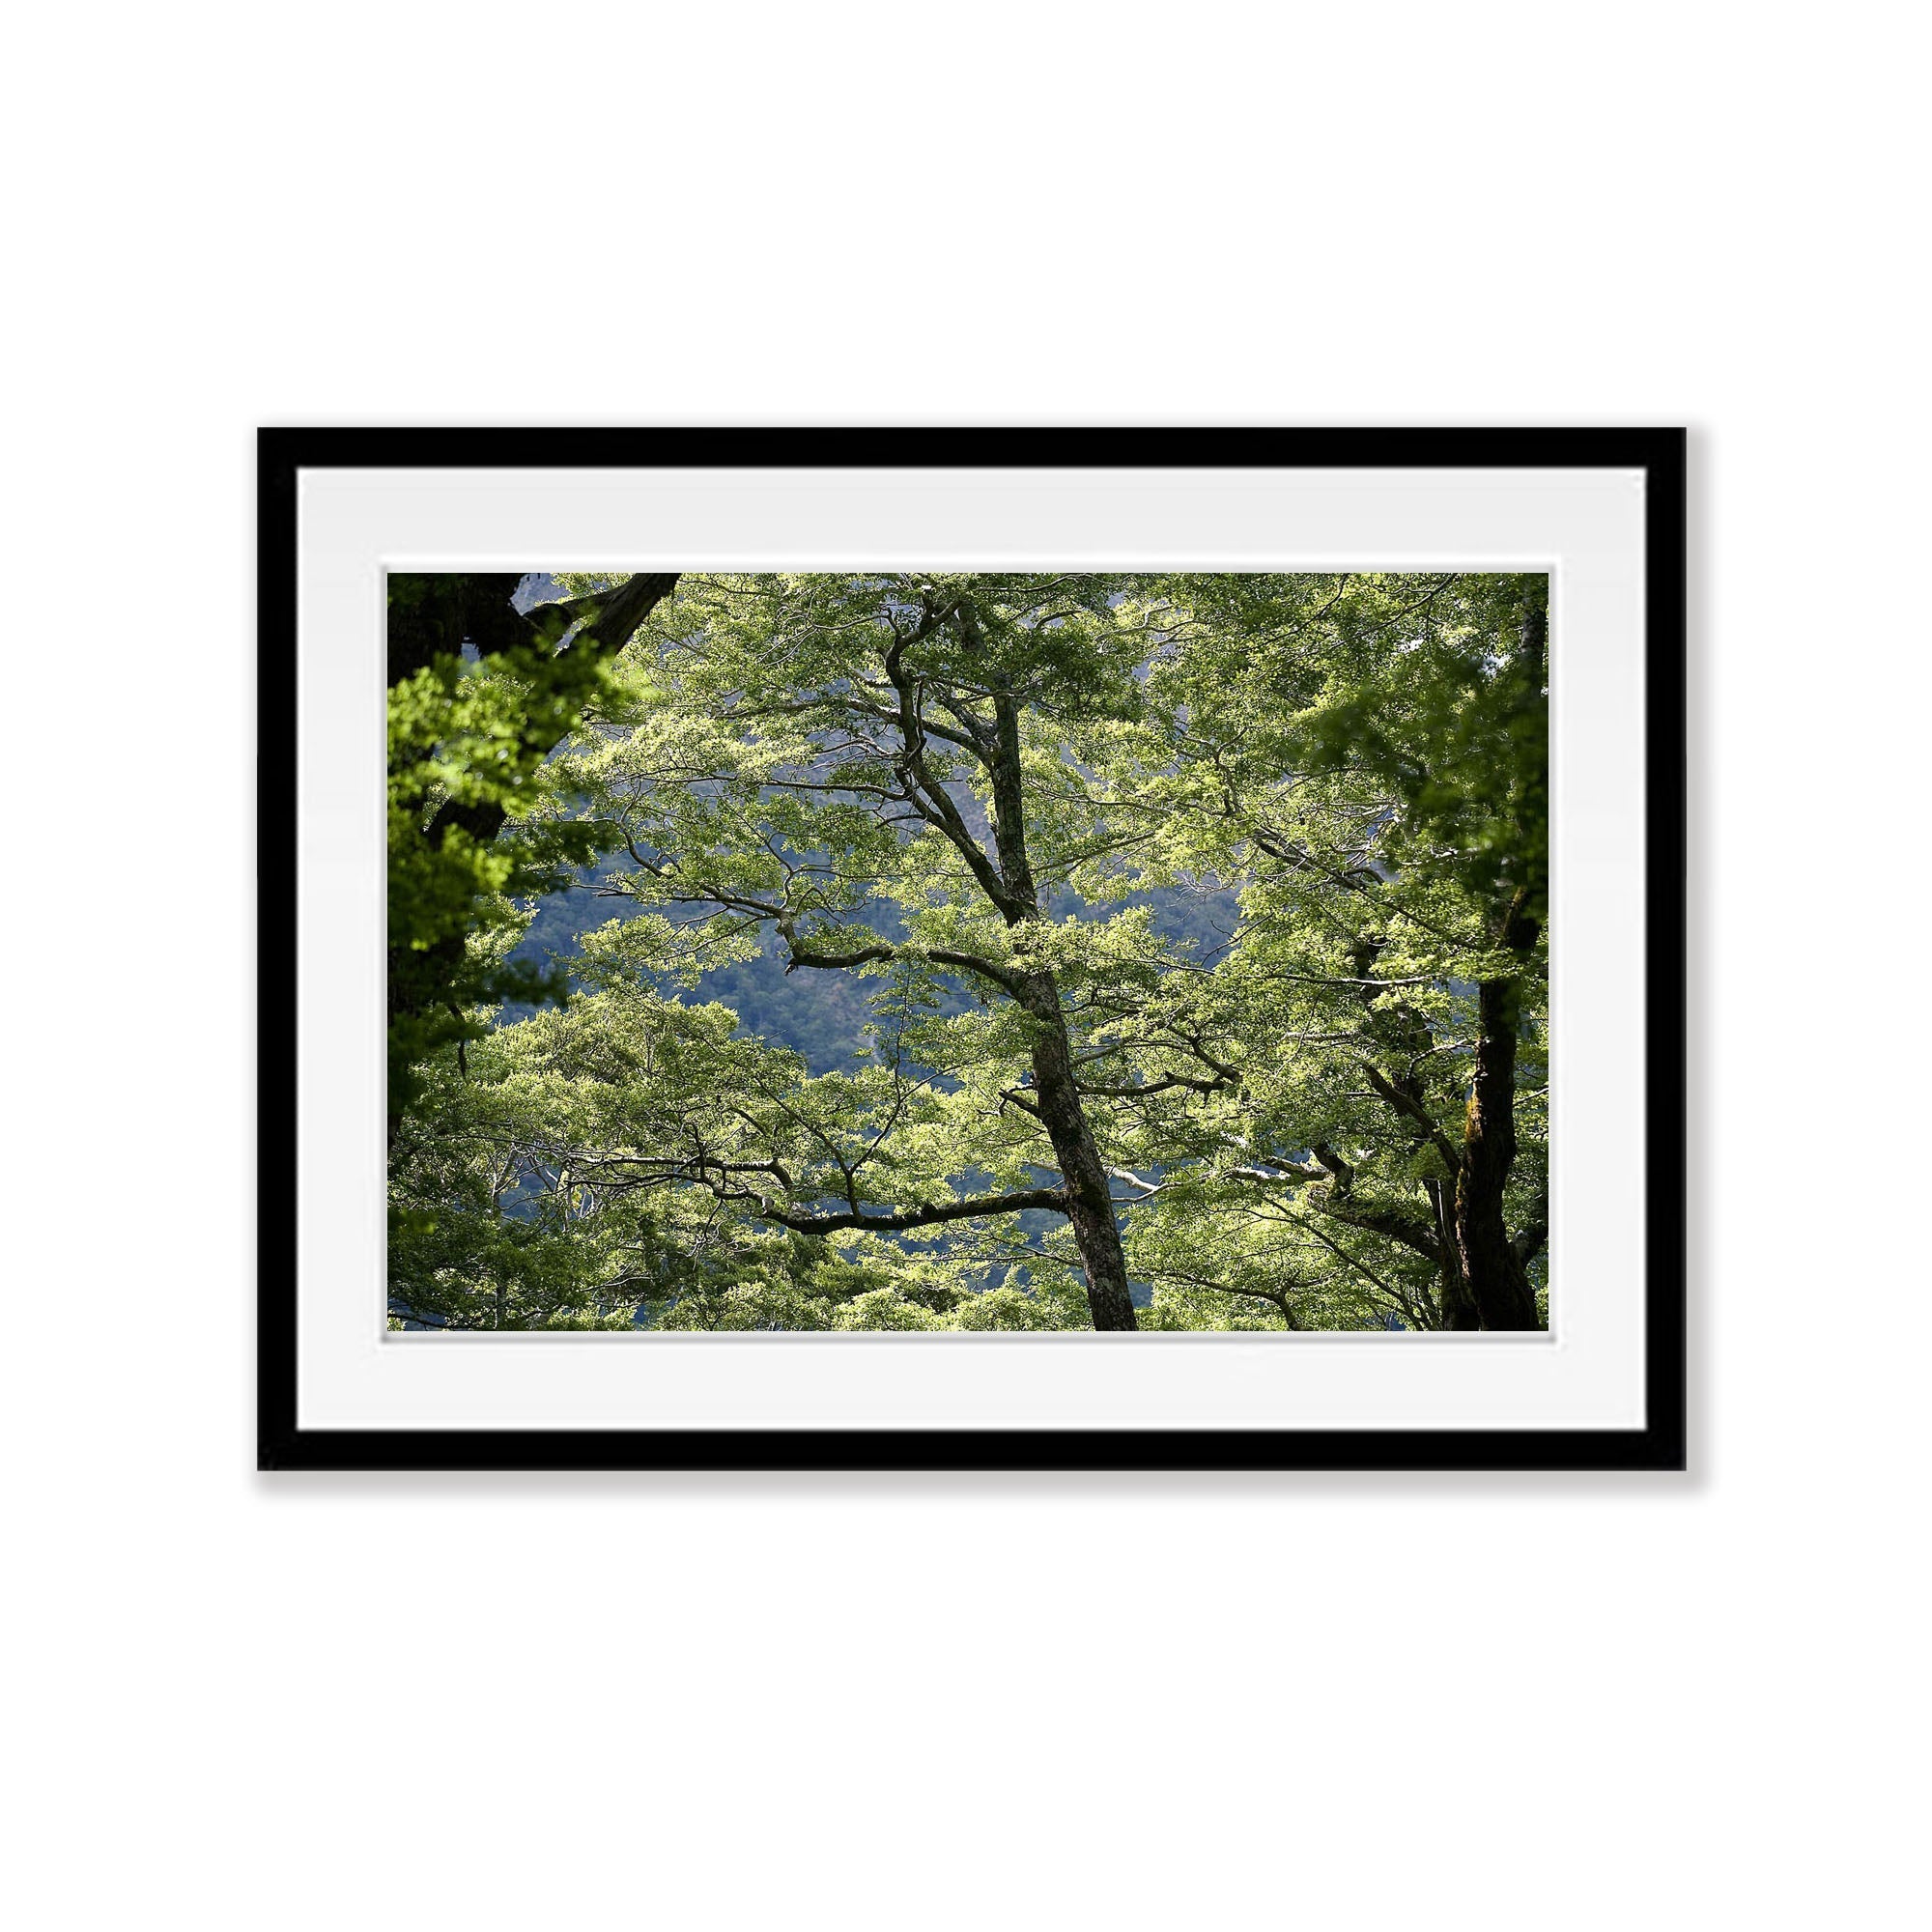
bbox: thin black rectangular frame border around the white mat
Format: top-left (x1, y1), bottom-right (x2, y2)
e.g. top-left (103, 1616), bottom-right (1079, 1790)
top-left (257, 429), bottom-right (1687, 1470)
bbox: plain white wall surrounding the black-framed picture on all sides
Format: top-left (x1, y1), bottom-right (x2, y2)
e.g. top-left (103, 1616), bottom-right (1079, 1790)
top-left (0, 0), bottom-right (1928, 1932)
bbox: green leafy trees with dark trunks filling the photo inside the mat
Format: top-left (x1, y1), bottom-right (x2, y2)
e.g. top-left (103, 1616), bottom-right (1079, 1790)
top-left (390, 572), bottom-right (1548, 1329)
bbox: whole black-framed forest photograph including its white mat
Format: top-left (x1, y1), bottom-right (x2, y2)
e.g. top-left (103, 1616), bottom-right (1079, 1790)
top-left (259, 429), bottom-right (1685, 1470)
